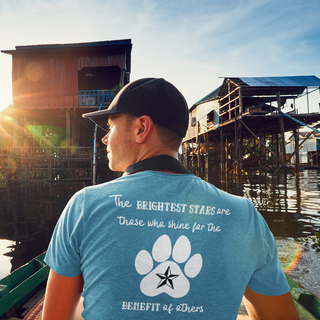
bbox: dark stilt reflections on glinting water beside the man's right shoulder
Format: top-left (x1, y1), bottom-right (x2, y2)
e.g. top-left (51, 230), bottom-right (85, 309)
top-left (243, 170), bottom-right (320, 238)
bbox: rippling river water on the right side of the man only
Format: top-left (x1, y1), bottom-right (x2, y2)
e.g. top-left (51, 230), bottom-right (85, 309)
top-left (243, 170), bottom-right (320, 298)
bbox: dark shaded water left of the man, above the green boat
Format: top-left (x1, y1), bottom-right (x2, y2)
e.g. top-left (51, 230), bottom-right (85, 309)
top-left (0, 181), bottom-right (84, 278)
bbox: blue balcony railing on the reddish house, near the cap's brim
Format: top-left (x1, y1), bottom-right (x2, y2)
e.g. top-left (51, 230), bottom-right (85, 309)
top-left (78, 90), bottom-right (115, 106)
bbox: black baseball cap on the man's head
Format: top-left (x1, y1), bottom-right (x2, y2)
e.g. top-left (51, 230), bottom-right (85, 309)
top-left (82, 78), bottom-right (189, 137)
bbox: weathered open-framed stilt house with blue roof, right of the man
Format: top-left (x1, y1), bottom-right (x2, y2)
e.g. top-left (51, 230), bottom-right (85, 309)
top-left (182, 76), bottom-right (320, 189)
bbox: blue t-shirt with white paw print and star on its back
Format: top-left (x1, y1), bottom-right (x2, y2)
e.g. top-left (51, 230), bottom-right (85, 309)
top-left (46, 171), bottom-right (289, 320)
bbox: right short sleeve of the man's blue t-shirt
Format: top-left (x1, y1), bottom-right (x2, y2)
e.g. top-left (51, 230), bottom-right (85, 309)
top-left (247, 205), bottom-right (290, 296)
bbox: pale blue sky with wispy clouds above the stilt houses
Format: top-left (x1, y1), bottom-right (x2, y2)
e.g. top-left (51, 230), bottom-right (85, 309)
top-left (0, 0), bottom-right (320, 112)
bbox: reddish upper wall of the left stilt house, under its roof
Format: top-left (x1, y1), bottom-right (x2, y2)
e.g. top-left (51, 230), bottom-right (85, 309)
top-left (12, 49), bottom-right (125, 109)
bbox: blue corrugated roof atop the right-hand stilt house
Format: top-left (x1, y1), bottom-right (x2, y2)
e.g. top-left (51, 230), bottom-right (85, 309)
top-left (239, 76), bottom-right (320, 87)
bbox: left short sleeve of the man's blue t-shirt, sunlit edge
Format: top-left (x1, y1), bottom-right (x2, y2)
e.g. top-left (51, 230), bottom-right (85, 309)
top-left (45, 190), bottom-right (84, 277)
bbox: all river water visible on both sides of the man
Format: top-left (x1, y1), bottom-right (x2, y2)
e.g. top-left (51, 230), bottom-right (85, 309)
top-left (0, 170), bottom-right (320, 297)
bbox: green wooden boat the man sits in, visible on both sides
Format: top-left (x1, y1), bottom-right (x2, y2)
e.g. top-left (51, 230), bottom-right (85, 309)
top-left (0, 252), bottom-right (320, 320)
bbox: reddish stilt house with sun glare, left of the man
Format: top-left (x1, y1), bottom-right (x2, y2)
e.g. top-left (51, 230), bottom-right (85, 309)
top-left (0, 39), bottom-right (132, 183)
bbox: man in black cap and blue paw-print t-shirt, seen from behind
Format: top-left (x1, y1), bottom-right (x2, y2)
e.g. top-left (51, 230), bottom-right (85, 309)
top-left (43, 78), bottom-right (298, 320)
